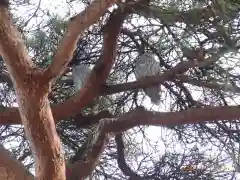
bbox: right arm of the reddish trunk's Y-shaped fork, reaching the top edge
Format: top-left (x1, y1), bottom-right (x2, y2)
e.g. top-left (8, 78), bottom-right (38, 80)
top-left (44, 0), bottom-right (118, 80)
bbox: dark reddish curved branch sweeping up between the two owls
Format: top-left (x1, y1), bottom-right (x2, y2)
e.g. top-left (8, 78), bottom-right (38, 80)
top-left (52, 9), bottom-right (126, 122)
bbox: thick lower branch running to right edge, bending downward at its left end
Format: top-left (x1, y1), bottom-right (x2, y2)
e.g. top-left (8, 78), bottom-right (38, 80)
top-left (65, 106), bottom-right (240, 179)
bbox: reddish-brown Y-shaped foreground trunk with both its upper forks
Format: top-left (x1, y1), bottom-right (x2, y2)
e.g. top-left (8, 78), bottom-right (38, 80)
top-left (0, 0), bottom-right (121, 180)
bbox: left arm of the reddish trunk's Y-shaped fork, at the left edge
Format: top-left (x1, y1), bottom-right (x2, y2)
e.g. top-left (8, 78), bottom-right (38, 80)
top-left (0, 6), bottom-right (34, 81)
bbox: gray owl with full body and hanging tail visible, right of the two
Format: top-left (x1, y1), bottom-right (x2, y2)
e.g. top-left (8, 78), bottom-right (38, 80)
top-left (134, 53), bottom-right (161, 105)
